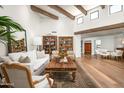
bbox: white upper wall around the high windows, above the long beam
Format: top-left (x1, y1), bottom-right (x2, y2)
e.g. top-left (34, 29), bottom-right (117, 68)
top-left (74, 6), bottom-right (124, 32)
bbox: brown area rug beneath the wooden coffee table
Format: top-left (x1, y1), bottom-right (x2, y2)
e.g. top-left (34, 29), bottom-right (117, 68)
top-left (53, 71), bottom-right (96, 88)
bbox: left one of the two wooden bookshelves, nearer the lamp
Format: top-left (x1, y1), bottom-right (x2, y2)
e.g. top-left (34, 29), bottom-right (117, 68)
top-left (43, 36), bottom-right (57, 54)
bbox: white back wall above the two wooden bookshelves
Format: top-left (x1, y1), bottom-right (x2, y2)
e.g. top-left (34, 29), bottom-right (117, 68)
top-left (34, 18), bottom-right (74, 36)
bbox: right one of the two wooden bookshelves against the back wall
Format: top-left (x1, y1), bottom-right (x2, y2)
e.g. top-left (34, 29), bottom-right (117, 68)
top-left (59, 36), bottom-right (73, 52)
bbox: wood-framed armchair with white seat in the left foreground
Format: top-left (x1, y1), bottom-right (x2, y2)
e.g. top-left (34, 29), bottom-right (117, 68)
top-left (2, 63), bottom-right (53, 88)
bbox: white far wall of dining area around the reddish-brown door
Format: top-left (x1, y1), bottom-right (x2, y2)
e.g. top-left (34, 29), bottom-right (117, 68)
top-left (82, 34), bottom-right (124, 55)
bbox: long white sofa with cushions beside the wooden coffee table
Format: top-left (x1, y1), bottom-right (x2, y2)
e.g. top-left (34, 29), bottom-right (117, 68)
top-left (8, 50), bottom-right (50, 75)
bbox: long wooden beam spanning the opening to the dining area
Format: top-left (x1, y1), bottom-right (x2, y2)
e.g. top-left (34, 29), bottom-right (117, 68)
top-left (74, 23), bottom-right (124, 35)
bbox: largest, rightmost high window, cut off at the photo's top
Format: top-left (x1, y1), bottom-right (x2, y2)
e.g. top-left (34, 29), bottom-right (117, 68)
top-left (109, 5), bottom-right (123, 14)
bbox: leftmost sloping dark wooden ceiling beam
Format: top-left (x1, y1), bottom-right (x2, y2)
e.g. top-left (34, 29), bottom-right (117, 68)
top-left (31, 5), bottom-right (59, 20)
